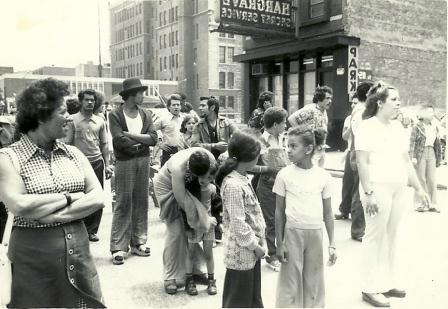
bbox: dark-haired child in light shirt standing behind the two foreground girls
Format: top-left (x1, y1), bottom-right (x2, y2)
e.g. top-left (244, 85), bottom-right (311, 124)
top-left (256, 106), bottom-right (289, 271)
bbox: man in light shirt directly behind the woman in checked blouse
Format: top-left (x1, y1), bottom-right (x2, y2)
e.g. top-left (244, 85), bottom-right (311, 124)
top-left (65, 89), bottom-right (112, 242)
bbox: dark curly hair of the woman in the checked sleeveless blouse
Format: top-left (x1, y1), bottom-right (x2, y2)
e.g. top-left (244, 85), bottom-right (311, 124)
top-left (16, 77), bottom-right (70, 134)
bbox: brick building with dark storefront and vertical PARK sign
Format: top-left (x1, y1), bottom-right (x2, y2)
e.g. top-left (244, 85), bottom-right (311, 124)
top-left (228, 0), bottom-right (446, 149)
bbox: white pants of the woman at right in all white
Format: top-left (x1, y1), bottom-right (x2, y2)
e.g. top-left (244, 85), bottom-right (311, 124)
top-left (360, 183), bottom-right (409, 293)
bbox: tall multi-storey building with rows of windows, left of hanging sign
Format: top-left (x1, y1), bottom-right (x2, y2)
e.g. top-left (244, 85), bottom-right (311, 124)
top-left (110, 0), bottom-right (244, 122)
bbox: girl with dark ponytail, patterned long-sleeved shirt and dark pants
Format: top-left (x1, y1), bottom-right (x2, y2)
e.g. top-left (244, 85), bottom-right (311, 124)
top-left (216, 131), bottom-right (266, 308)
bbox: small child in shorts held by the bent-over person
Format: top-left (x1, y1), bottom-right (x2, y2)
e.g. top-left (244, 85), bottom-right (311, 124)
top-left (184, 163), bottom-right (218, 295)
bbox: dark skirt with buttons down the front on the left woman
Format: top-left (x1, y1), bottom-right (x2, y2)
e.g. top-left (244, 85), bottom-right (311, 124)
top-left (9, 221), bottom-right (105, 308)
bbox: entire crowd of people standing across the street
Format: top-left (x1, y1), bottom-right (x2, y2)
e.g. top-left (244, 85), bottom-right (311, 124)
top-left (0, 78), bottom-right (441, 308)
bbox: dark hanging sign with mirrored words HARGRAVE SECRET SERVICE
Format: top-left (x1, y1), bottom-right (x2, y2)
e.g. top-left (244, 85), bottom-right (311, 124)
top-left (218, 0), bottom-right (295, 34)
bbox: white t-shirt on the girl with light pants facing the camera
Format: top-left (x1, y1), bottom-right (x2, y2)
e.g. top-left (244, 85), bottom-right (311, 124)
top-left (272, 164), bottom-right (331, 229)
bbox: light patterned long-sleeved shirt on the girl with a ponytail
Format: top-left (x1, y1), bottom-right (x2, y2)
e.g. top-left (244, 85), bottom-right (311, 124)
top-left (221, 171), bottom-right (266, 270)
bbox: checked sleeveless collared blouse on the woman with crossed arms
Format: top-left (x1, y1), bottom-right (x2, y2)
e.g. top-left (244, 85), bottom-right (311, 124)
top-left (1, 135), bottom-right (85, 228)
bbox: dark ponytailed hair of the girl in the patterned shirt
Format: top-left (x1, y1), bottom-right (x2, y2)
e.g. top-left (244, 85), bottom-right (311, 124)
top-left (216, 131), bottom-right (261, 186)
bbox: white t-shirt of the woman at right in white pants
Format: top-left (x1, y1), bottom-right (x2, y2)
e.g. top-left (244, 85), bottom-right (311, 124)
top-left (355, 117), bottom-right (409, 183)
